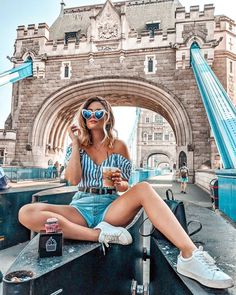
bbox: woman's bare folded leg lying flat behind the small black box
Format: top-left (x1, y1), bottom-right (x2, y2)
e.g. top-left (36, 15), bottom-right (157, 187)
top-left (19, 203), bottom-right (100, 241)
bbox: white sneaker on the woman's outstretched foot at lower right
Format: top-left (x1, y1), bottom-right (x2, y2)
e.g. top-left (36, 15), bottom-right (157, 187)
top-left (177, 247), bottom-right (234, 289)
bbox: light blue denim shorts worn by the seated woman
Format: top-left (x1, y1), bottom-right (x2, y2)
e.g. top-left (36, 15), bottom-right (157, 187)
top-left (70, 192), bottom-right (119, 228)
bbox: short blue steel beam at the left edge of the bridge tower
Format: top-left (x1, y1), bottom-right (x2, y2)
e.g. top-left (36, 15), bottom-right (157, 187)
top-left (0, 60), bottom-right (33, 87)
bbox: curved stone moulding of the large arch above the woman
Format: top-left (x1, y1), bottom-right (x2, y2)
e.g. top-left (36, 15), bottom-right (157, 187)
top-left (31, 77), bottom-right (192, 166)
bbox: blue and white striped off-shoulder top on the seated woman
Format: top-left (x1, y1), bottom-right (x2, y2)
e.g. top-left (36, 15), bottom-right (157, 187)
top-left (64, 146), bottom-right (132, 187)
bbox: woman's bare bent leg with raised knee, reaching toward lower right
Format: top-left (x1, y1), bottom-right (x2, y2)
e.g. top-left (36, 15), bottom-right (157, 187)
top-left (105, 182), bottom-right (196, 257)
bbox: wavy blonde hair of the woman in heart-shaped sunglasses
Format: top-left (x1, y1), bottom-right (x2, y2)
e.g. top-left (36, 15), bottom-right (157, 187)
top-left (78, 96), bottom-right (115, 148)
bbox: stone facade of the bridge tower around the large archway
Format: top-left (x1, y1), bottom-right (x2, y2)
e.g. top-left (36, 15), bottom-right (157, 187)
top-left (0, 0), bottom-right (236, 180)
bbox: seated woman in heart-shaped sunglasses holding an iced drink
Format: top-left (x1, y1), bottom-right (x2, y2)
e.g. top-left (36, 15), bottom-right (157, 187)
top-left (19, 97), bottom-right (233, 288)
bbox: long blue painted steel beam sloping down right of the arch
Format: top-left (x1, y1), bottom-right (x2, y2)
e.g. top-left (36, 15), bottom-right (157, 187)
top-left (191, 43), bottom-right (236, 169)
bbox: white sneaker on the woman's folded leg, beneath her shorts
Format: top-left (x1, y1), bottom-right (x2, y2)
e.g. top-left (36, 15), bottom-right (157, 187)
top-left (95, 221), bottom-right (133, 247)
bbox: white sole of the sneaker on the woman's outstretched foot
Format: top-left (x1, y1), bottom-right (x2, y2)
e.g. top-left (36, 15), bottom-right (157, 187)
top-left (177, 268), bottom-right (234, 289)
